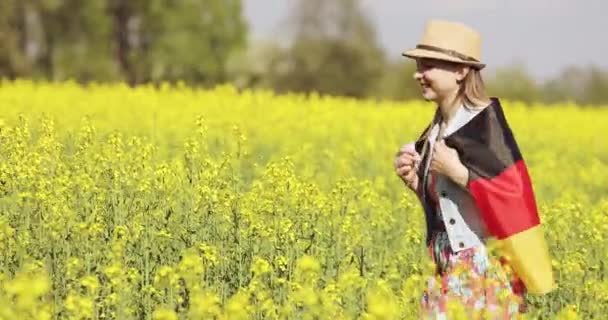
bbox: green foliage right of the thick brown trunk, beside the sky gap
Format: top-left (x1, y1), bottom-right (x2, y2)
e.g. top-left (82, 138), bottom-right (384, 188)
top-left (134, 0), bottom-right (245, 84)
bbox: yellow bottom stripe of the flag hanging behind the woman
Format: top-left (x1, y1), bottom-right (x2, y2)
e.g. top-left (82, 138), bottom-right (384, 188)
top-left (498, 225), bottom-right (555, 295)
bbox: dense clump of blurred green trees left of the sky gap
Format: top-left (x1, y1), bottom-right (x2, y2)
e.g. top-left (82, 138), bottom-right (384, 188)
top-left (0, 0), bottom-right (246, 85)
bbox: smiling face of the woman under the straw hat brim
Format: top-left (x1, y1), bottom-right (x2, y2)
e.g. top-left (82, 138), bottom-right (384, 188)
top-left (414, 58), bottom-right (468, 103)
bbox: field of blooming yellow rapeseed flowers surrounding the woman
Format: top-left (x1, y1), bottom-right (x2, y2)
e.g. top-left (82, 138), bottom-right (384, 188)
top-left (0, 81), bottom-right (608, 319)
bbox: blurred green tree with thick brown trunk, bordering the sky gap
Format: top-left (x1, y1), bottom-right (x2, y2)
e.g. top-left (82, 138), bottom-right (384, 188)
top-left (111, 0), bottom-right (246, 85)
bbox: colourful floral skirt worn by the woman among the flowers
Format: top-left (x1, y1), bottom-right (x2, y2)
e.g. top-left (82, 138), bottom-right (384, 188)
top-left (421, 231), bottom-right (525, 319)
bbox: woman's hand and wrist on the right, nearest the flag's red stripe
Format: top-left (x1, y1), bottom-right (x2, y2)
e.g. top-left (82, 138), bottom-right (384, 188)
top-left (429, 139), bottom-right (469, 188)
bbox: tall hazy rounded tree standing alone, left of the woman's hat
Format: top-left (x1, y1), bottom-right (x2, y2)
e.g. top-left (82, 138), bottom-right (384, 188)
top-left (268, 0), bottom-right (384, 97)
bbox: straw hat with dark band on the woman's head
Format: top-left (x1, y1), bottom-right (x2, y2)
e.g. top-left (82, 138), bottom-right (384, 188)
top-left (403, 20), bottom-right (486, 69)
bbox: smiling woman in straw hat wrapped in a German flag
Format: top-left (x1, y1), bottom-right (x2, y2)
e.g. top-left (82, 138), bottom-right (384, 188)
top-left (395, 20), bottom-right (554, 319)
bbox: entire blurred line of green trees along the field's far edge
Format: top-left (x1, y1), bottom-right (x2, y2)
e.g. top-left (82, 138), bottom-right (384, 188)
top-left (0, 0), bottom-right (608, 105)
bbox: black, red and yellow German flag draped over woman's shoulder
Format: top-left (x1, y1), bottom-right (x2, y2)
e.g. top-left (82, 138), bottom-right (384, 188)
top-left (436, 98), bottom-right (555, 295)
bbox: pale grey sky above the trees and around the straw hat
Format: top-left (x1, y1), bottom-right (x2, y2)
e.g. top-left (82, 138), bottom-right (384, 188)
top-left (244, 0), bottom-right (608, 80)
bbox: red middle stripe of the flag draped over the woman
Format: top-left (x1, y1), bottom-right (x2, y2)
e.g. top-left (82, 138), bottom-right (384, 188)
top-left (469, 160), bottom-right (540, 239)
